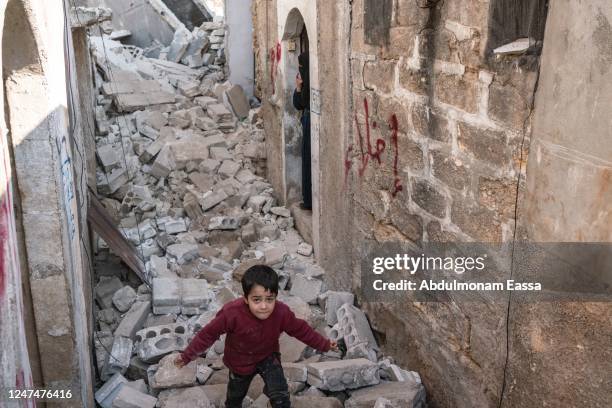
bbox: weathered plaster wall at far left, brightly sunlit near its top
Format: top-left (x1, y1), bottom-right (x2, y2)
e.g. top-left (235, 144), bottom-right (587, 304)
top-left (2, 0), bottom-right (93, 406)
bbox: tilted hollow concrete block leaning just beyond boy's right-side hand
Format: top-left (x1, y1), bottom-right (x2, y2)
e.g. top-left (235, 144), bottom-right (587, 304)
top-left (336, 303), bottom-right (379, 350)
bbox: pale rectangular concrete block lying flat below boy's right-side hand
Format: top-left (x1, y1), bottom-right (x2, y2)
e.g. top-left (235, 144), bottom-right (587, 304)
top-left (307, 358), bottom-right (380, 391)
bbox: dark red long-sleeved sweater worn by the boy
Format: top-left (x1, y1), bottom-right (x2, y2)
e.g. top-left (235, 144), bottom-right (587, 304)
top-left (182, 298), bottom-right (330, 375)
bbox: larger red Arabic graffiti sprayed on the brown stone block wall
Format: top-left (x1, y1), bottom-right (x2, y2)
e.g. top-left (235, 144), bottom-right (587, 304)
top-left (344, 98), bottom-right (404, 197)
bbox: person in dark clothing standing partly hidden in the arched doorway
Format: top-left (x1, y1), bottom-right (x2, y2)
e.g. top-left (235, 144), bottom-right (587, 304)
top-left (293, 52), bottom-right (312, 210)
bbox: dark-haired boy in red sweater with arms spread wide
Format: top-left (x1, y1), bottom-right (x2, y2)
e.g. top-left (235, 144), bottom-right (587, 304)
top-left (175, 265), bottom-right (338, 408)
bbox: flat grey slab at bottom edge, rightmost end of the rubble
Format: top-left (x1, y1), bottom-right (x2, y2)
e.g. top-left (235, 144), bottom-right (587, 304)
top-left (344, 382), bottom-right (426, 408)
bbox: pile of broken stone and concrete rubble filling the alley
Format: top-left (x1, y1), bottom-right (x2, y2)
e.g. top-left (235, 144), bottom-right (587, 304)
top-left (91, 23), bottom-right (425, 408)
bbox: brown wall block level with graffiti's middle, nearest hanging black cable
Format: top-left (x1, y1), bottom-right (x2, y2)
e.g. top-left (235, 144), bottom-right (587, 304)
top-left (457, 122), bottom-right (510, 166)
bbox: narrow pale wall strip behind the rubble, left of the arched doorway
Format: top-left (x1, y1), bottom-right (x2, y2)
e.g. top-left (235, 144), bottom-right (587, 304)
top-left (225, 0), bottom-right (255, 97)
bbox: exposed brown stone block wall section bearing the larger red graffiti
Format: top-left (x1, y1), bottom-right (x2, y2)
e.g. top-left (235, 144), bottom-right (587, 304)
top-left (346, 0), bottom-right (537, 407)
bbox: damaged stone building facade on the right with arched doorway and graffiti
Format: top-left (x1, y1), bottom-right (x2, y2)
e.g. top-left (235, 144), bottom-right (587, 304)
top-left (253, 0), bottom-right (612, 407)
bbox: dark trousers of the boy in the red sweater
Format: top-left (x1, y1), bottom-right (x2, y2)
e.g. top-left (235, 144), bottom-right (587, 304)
top-left (225, 353), bottom-right (291, 408)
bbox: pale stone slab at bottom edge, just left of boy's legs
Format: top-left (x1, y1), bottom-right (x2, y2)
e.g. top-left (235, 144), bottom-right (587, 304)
top-left (158, 384), bottom-right (214, 408)
